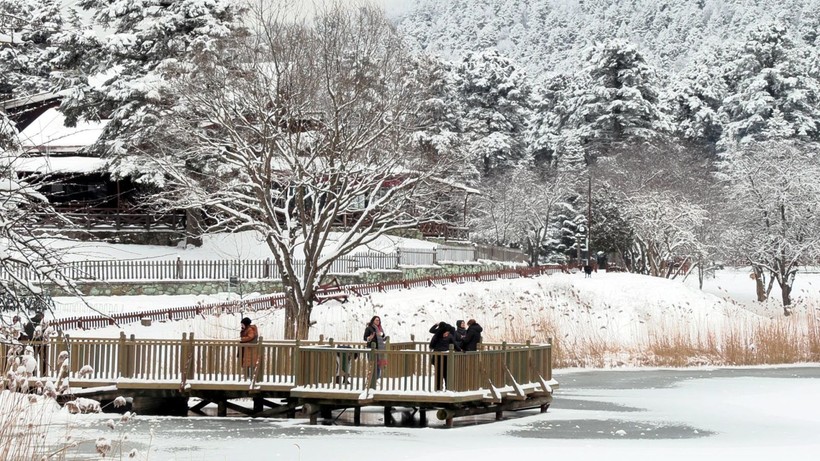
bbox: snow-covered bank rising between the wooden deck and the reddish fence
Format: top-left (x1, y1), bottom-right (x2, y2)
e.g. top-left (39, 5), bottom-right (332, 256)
top-left (64, 272), bottom-right (820, 365)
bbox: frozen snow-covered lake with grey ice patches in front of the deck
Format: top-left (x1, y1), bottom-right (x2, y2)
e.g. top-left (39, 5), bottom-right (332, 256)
top-left (57, 365), bottom-right (820, 461)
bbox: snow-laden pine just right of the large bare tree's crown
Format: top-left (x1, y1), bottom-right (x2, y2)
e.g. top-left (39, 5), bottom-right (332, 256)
top-left (456, 51), bottom-right (530, 175)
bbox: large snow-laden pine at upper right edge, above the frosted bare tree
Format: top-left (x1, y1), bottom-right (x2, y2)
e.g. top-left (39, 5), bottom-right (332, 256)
top-left (721, 22), bottom-right (820, 147)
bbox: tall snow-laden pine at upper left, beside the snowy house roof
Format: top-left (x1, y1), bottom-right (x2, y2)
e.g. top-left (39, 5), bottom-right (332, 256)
top-left (60, 0), bottom-right (243, 184)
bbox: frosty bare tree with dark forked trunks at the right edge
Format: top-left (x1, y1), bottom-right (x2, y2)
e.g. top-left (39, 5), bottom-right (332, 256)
top-left (721, 141), bottom-right (820, 315)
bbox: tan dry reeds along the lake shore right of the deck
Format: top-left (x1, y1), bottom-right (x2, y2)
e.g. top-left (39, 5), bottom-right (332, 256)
top-left (520, 305), bottom-right (820, 368)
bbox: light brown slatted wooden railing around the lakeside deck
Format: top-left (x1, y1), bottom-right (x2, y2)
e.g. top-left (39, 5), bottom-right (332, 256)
top-left (0, 333), bottom-right (552, 398)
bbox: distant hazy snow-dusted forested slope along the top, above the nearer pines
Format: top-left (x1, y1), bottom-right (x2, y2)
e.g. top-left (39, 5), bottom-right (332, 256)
top-left (399, 0), bottom-right (820, 77)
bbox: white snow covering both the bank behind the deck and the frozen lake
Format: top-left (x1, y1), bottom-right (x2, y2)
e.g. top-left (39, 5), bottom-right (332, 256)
top-left (0, 234), bottom-right (820, 461)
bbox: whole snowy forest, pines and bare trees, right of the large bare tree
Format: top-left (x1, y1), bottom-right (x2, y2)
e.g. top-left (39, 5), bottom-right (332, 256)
top-left (397, 0), bottom-right (820, 312)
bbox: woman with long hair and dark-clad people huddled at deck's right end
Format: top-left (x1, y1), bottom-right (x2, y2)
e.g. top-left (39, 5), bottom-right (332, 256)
top-left (362, 315), bottom-right (483, 390)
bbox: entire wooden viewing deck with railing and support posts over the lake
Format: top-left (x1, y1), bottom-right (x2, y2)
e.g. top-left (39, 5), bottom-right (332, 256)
top-left (0, 334), bottom-right (557, 425)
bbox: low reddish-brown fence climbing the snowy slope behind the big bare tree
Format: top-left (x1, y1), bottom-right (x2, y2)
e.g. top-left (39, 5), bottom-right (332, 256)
top-left (52, 265), bottom-right (566, 330)
